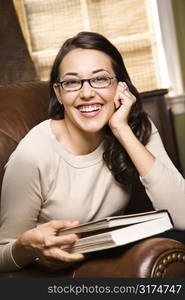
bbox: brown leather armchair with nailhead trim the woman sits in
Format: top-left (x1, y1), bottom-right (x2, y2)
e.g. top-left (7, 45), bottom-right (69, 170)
top-left (0, 81), bottom-right (185, 278)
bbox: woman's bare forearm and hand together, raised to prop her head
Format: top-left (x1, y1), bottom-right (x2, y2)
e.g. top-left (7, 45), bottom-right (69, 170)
top-left (109, 82), bottom-right (155, 177)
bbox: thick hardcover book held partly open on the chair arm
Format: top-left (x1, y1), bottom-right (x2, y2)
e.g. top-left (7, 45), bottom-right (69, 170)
top-left (59, 210), bottom-right (173, 253)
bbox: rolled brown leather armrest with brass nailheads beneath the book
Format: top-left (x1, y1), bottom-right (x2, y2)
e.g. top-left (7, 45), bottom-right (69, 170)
top-left (74, 238), bottom-right (185, 278)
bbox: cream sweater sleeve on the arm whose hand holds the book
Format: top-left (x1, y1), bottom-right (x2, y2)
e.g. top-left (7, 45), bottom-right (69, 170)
top-left (0, 152), bottom-right (42, 271)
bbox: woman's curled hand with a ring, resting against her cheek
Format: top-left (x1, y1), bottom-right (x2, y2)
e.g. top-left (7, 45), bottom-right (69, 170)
top-left (109, 82), bottom-right (136, 133)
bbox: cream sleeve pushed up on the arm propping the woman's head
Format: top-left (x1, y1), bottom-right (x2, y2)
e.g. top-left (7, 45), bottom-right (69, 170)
top-left (140, 124), bottom-right (185, 230)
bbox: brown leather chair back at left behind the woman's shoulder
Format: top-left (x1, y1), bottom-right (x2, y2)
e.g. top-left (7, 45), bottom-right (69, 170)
top-left (0, 81), bottom-right (49, 195)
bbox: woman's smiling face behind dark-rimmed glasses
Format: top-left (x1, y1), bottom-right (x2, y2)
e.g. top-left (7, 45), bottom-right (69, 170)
top-left (54, 48), bottom-right (117, 133)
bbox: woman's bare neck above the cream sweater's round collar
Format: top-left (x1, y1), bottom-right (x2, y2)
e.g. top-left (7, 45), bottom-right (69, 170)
top-left (51, 119), bottom-right (104, 155)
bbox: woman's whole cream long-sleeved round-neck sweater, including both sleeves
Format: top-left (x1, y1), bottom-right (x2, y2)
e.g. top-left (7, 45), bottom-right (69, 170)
top-left (0, 120), bottom-right (185, 271)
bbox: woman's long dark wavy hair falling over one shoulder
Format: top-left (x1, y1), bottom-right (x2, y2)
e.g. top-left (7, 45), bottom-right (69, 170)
top-left (49, 32), bottom-right (151, 184)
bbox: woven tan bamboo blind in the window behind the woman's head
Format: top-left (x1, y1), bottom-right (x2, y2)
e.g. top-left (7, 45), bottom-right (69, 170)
top-left (14, 0), bottom-right (162, 91)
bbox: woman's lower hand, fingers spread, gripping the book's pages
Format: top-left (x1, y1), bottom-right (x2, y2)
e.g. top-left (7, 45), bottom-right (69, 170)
top-left (12, 220), bottom-right (84, 269)
